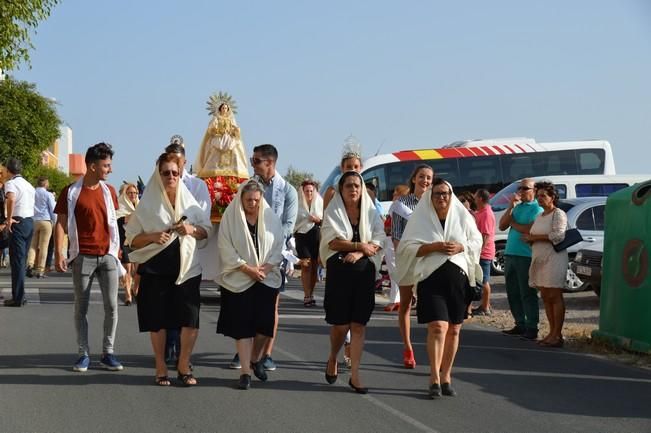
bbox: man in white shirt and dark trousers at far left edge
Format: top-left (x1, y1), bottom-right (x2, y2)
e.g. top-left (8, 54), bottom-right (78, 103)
top-left (4, 158), bottom-right (35, 307)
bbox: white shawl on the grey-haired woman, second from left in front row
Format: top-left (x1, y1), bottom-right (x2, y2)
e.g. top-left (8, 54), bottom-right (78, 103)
top-left (215, 180), bottom-right (284, 293)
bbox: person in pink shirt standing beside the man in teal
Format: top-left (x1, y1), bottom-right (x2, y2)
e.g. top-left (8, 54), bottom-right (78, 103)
top-left (471, 188), bottom-right (495, 316)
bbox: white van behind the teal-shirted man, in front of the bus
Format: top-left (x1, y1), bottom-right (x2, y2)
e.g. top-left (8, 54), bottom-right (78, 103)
top-left (490, 174), bottom-right (651, 275)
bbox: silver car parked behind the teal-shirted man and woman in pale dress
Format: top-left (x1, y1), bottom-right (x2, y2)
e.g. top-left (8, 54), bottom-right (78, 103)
top-left (495, 197), bottom-right (607, 292)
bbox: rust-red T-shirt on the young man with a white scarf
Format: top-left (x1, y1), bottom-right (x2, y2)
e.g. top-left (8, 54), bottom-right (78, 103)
top-left (54, 181), bottom-right (118, 256)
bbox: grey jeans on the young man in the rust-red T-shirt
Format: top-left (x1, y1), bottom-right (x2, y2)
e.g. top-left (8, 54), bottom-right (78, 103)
top-left (72, 254), bottom-right (119, 355)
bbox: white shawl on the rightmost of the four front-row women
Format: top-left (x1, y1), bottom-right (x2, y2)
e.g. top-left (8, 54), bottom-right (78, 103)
top-left (396, 184), bottom-right (482, 286)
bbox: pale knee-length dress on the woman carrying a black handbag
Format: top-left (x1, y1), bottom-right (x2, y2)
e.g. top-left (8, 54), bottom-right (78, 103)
top-left (529, 208), bottom-right (568, 288)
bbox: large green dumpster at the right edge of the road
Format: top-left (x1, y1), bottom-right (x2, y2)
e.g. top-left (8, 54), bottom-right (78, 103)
top-left (592, 180), bottom-right (651, 353)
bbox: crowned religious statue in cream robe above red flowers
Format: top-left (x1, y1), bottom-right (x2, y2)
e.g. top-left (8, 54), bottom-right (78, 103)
top-left (194, 92), bottom-right (249, 222)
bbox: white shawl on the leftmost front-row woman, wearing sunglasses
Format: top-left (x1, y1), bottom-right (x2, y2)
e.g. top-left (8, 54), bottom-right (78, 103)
top-left (125, 166), bottom-right (212, 284)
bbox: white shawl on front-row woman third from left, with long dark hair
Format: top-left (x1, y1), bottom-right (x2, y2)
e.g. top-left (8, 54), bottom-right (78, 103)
top-left (319, 176), bottom-right (386, 271)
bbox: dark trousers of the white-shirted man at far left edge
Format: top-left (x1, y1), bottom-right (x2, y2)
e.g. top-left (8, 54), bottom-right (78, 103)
top-left (9, 217), bottom-right (34, 302)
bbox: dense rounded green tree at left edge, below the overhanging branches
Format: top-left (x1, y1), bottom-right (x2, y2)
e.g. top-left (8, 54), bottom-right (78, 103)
top-left (0, 78), bottom-right (61, 175)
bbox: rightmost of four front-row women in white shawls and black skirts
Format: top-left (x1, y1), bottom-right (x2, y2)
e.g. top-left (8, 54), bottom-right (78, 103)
top-left (397, 178), bottom-right (482, 398)
